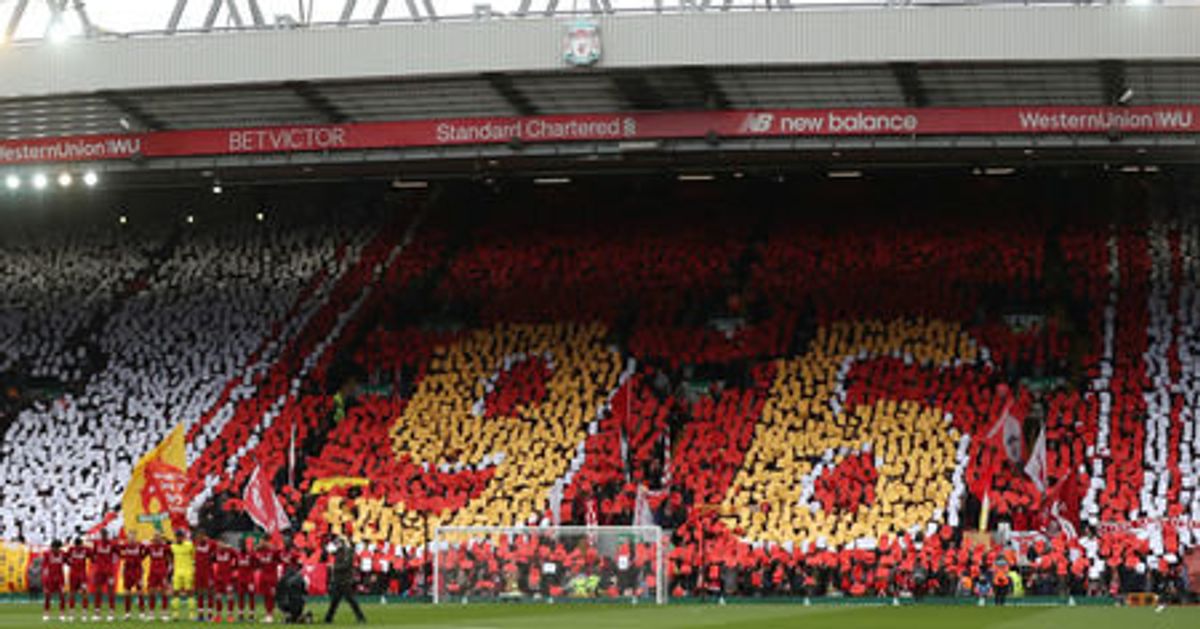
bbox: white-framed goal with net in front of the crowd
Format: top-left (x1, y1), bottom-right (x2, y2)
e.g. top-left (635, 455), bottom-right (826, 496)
top-left (432, 526), bottom-right (667, 604)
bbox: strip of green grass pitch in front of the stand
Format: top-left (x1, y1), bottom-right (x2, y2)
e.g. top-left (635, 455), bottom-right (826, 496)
top-left (0, 603), bottom-right (1200, 629)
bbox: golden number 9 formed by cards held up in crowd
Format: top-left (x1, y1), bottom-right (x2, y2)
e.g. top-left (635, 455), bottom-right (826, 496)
top-left (310, 324), bottom-right (623, 546)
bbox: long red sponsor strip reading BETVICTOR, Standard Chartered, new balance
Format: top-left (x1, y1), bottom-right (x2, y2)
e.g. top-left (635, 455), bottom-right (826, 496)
top-left (0, 106), bottom-right (1200, 164)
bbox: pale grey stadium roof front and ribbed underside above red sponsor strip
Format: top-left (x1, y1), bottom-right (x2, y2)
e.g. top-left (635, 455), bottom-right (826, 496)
top-left (0, 0), bottom-right (1200, 110)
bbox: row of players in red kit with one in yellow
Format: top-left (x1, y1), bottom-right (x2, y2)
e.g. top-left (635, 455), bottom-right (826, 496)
top-left (42, 531), bottom-right (298, 623)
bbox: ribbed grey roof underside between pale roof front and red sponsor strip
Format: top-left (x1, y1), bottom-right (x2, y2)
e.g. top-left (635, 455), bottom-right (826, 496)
top-left (7, 61), bottom-right (1200, 139)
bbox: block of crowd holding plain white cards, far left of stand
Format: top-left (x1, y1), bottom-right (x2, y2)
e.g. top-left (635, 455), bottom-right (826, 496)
top-left (0, 208), bottom-right (362, 543)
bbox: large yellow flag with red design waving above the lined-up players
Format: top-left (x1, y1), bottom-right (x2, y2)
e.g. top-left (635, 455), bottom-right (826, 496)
top-left (121, 424), bottom-right (187, 540)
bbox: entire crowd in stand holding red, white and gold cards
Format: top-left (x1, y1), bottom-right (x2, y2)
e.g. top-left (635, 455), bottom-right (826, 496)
top-left (7, 178), bottom-right (1200, 597)
